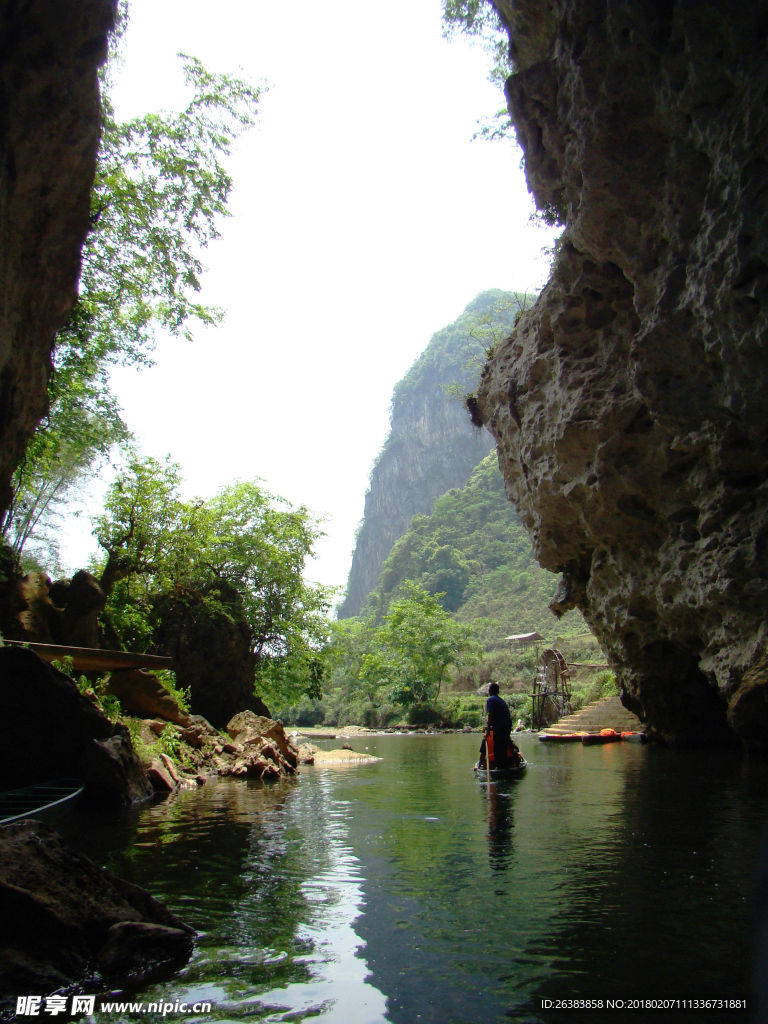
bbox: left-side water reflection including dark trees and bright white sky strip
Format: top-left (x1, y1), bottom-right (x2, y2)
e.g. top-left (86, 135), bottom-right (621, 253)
top-left (62, 774), bottom-right (385, 1024)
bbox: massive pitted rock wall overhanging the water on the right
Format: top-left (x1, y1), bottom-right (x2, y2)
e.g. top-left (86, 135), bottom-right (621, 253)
top-left (476, 0), bottom-right (768, 746)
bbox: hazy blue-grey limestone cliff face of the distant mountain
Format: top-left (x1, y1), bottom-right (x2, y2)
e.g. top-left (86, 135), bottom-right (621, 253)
top-left (339, 289), bottom-right (507, 618)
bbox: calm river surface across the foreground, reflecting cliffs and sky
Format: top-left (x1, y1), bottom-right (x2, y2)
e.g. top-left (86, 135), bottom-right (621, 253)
top-left (61, 735), bottom-right (768, 1024)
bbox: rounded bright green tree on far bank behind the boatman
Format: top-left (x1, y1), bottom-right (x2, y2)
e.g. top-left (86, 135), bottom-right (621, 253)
top-left (359, 581), bottom-right (482, 706)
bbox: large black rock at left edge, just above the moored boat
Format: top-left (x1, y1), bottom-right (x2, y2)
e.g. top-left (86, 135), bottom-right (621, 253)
top-left (0, 647), bottom-right (153, 804)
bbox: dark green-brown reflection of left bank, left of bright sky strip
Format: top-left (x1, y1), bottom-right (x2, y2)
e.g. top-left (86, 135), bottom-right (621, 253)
top-left (58, 780), bottom-right (335, 1007)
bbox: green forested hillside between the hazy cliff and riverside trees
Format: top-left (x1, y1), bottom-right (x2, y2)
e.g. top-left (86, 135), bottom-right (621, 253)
top-left (367, 454), bottom-right (587, 636)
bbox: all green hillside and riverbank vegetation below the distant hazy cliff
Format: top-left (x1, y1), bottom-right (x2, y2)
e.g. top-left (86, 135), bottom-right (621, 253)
top-left (280, 455), bottom-right (603, 727)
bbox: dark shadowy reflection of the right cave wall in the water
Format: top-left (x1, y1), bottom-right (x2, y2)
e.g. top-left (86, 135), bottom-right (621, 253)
top-left (526, 746), bottom-right (767, 1024)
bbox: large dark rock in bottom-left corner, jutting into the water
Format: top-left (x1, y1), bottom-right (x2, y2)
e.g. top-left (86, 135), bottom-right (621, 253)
top-left (0, 821), bottom-right (194, 1006)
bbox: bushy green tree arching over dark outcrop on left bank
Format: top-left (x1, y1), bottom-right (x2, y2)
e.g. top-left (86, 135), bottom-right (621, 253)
top-left (94, 457), bottom-right (334, 700)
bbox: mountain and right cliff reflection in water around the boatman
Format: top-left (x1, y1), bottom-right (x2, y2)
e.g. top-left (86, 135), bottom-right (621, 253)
top-left (319, 737), bottom-right (768, 1024)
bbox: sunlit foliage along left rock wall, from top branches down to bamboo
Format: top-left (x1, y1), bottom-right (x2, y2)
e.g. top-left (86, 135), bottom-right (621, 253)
top-left (0, 54), bottom-right (265, 556)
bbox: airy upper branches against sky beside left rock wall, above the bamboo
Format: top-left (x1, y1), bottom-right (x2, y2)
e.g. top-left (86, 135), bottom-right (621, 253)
top-left (66, 54), bottom-right (264, 376)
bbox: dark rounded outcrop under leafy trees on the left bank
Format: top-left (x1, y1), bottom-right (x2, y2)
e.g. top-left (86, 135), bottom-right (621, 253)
top-left (155, 583), bottom-right (269, 728)
